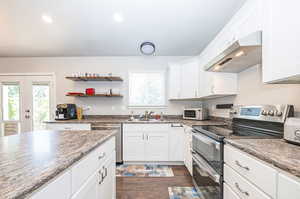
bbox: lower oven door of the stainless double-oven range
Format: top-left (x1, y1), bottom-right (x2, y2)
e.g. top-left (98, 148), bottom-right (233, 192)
top-left (193, 152), bottom-right (223, 199)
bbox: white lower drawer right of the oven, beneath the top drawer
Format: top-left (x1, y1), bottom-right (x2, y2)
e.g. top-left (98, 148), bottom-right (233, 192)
top-left (224, 164), bottom-right (271, 199)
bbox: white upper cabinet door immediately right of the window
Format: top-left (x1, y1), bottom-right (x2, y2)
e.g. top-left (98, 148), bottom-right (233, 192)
top-left (168, 64), bottom-right (181, 99)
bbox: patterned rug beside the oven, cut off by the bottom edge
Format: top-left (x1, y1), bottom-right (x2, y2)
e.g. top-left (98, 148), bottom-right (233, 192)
top-left (168, 186), bottom-right (219, 199)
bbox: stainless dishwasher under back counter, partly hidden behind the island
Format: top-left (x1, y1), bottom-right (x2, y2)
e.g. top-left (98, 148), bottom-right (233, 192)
top-left (91, 123), bottom-right (123, 164)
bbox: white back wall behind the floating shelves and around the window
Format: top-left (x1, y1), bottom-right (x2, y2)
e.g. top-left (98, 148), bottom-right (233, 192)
top-left (0, 57), bottom-right (202, 115)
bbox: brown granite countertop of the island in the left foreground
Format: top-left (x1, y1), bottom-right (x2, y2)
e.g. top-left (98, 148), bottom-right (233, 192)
top-left (0, 130), bottom-right (116, 199)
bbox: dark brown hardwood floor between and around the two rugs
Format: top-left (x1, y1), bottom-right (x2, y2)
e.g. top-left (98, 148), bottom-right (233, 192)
top-left (117, 166), bottom-right (193, 199)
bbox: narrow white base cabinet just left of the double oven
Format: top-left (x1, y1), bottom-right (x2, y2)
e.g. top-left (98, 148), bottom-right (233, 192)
top-left (184, 127), bottom-right (193, 175)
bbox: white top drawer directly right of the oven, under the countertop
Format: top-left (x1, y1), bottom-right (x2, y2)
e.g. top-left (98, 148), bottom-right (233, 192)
top-left (224, 145), bottom-right (277, 198)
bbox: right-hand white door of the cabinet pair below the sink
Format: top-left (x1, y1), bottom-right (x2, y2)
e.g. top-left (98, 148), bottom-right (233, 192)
top-left (145, 132), bottom-right (169, 161)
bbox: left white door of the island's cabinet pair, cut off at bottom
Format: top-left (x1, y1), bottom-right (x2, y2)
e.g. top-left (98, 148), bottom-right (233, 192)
top-left (72, 172), bottom-right (99, 199)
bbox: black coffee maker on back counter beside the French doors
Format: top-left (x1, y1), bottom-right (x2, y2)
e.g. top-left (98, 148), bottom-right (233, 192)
top-left (55, 104), bottom-right (77, 120)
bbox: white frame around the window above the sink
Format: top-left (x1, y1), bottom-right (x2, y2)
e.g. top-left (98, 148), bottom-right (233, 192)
top-left (127, 70), bottom-right (167, 109)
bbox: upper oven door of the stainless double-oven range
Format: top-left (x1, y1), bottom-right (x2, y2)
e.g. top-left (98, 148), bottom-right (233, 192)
top-left (192, 132), bottom-right (223, 175)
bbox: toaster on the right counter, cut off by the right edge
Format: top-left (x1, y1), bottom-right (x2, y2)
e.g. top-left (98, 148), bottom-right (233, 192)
top-left (284, 117), bottom-right (300, 144)
